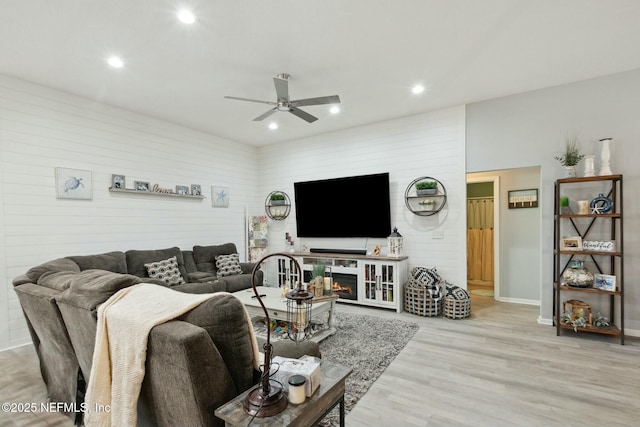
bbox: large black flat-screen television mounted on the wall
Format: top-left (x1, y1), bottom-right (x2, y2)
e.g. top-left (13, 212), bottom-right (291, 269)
top-left (293, 173), bottom-right (391, 237)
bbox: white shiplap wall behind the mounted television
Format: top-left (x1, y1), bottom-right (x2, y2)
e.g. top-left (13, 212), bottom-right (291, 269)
top-left (260, 107), bottom-right (466, 287)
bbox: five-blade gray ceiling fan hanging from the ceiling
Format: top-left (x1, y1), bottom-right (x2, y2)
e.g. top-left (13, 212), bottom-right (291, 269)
top-left (225, 74), bottom-right (340, 123)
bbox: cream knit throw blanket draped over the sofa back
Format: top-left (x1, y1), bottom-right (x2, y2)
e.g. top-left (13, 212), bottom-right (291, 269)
top-left (85, 283), bottom-right (260, 427)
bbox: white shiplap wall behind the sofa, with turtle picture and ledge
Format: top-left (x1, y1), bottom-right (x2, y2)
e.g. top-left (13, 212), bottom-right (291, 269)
top-left (0, 75), bottom-right (262, 349)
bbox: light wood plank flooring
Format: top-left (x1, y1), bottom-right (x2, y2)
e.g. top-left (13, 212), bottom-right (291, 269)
top-left (0, 296), bottom-right (640, 427)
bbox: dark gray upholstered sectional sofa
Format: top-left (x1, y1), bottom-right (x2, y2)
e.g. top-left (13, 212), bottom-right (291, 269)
top-left (13, 243), bottom-right (320, 426)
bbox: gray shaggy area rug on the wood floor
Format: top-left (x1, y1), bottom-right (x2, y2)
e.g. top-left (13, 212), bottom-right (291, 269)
top-left (318, 312), bottom-right (419, 427)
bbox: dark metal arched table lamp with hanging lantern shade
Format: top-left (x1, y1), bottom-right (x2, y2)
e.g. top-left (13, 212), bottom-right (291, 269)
top-left (243, 253), bottom-right (313, 418)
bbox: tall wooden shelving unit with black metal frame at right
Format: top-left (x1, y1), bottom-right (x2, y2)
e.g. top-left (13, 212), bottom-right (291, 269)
top-left (553, 175), bottom-right (624, 344)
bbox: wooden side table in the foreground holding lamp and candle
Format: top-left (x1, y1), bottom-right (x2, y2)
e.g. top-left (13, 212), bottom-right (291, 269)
top-left (215, 360), bottom-right (352, 427)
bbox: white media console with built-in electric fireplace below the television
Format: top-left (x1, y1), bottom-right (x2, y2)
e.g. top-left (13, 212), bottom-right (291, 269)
top-left (278, 252), bottom-right (408, 313)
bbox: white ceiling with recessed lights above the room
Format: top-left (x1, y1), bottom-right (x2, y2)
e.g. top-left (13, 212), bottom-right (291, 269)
top-left (0, 0), bottom-right (640, 145)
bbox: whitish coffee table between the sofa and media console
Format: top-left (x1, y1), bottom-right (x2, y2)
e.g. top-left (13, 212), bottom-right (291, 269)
top-left (233, 286), bottom-right (338, 342)
